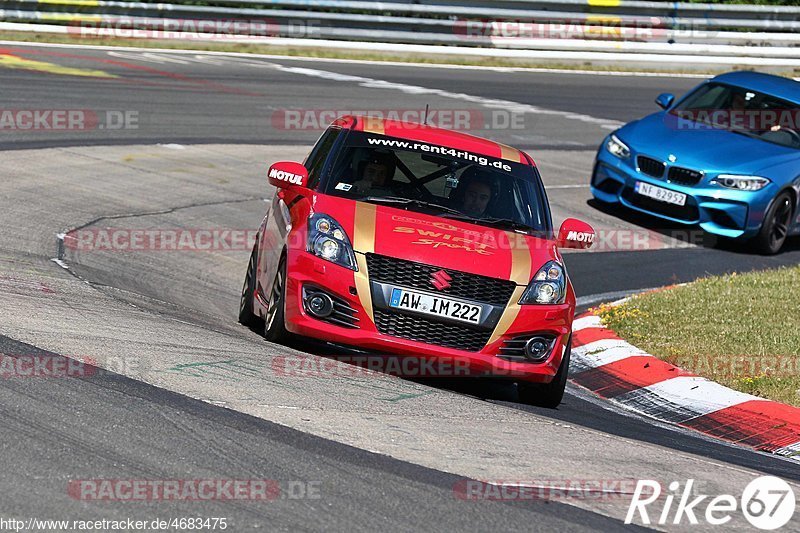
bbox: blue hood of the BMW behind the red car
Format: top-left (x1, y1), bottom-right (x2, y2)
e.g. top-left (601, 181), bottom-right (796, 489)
top-left (617, 111), bottom-right (800, 174)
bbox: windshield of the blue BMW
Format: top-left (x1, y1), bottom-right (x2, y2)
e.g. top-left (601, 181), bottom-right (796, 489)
top-left (670, 83), bottom-right (800, 149)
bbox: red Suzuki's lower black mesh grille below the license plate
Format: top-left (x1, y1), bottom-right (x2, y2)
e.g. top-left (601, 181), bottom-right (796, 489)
top-left (375, 309), bottom-right (492, 352)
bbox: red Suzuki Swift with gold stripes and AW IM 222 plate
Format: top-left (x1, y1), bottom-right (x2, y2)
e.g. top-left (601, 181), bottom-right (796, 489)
top-left (239, 116), bottom-right (594, 407)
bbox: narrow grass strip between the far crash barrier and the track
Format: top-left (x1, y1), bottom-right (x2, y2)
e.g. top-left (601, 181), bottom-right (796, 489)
top-left (0, 31), bottom-right (788, 76)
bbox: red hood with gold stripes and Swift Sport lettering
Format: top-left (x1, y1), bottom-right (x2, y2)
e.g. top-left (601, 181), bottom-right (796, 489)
top-left (313, 195), bottom-right (561, 285)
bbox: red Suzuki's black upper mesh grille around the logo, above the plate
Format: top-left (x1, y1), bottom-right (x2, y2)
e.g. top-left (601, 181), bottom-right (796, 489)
top-left (367, 254), bottom-right (516, 306)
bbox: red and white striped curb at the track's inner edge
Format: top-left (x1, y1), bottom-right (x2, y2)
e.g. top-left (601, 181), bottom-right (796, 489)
top-left (570, 302), bottom-right (800, 460)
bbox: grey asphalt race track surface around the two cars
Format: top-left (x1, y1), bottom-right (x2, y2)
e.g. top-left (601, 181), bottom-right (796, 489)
top-left (0, 45), bottom-right (800, 531)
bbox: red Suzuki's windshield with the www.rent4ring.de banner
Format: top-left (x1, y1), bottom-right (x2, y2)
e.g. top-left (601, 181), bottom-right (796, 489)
top-left (322, 131), bottom-right (549, 234)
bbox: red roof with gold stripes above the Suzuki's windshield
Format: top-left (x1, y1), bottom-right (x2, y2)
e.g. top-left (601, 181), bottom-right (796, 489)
top-left (331, 115), bottom-right (536, 166)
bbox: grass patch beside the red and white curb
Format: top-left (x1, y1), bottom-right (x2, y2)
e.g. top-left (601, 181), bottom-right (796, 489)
top-left (598, 266), bottom-right (800, 406)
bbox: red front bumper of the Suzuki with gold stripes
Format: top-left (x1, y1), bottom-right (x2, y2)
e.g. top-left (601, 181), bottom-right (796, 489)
top-left (278, 250), bottom-right (575, 383)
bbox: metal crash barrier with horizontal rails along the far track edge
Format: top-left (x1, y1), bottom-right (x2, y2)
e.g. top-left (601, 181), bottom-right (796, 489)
top-left (0, 0), bottom-right (800, 67)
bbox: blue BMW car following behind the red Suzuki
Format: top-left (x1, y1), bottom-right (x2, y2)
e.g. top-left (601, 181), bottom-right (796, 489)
top-left (591, 72), bottom-right (800, 254)
